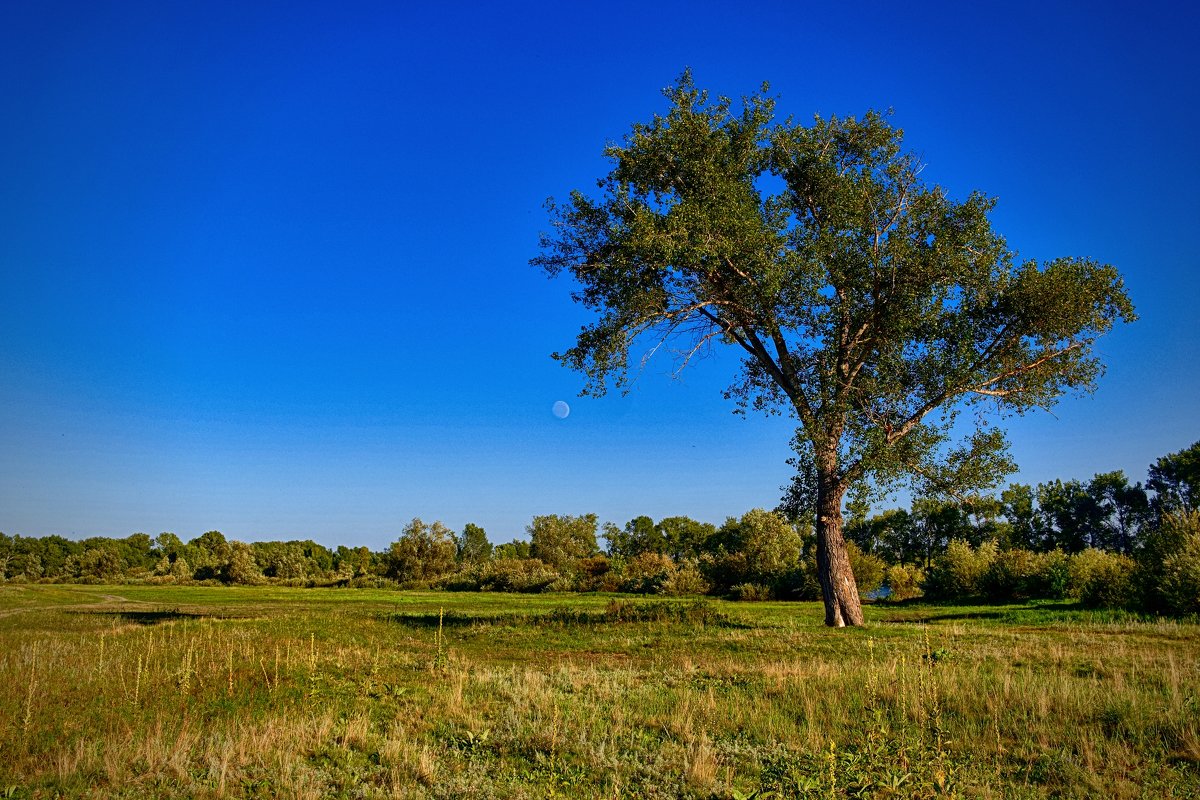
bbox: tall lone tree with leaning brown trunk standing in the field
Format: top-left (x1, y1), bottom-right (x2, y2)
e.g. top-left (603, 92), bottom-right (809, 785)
top-left (533, 73), bottom-right (1134, 626)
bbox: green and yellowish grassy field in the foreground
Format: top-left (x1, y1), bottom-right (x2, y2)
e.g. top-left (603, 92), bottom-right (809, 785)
top-left (0, 585), bottom-right (1200, 798)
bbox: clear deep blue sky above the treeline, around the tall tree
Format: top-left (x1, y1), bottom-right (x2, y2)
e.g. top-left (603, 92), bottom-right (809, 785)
top-left (0, 0), bottom-right (1200, 548)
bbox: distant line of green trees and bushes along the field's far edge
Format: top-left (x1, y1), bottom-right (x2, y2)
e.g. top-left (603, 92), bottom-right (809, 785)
top-left (0, 441), bottom-right (1200, 614)
